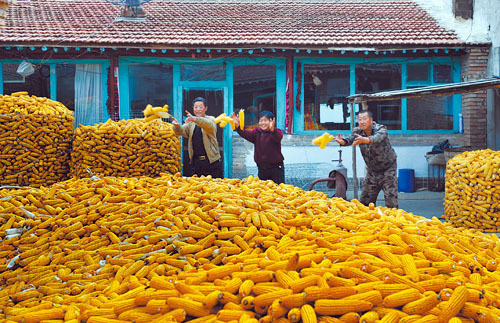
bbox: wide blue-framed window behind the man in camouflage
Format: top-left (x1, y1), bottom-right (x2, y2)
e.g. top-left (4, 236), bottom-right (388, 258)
top-left (293, 57), bottom-right (461, 134)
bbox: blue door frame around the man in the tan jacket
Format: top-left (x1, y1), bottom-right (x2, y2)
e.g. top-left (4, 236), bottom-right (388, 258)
top-left (174, 81), bottom-right (233, 178)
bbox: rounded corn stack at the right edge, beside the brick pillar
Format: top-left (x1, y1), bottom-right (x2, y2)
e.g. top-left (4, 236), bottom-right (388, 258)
top-left (443, 149), bottom-right (500, 232)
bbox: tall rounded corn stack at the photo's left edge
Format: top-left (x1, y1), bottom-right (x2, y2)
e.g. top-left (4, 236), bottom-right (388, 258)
top-left (0, 92), bottom-right (73, 187)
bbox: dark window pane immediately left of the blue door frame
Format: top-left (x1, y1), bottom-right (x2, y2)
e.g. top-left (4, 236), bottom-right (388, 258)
top-left (129, 65), bottom-right (173, 118)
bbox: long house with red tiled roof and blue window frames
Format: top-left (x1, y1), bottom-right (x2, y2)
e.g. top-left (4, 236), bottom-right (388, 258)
top-left (0, 0), bottom-right (491, 188)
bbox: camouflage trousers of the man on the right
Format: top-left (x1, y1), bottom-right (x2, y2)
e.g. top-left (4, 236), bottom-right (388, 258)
top-left (359, 164), bottom-right (398, 208)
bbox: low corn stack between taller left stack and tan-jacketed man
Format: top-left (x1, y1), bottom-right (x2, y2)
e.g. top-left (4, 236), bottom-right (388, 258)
top-left (71, 119), bottom-right (181, 177)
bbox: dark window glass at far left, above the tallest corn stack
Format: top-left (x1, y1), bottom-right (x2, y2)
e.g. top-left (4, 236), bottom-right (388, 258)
top-left (3, 63), bottom-right (50, 98)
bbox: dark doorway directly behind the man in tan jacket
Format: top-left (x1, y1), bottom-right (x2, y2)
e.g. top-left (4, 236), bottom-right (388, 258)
top-left (182, 87), bottom-right (224, 176)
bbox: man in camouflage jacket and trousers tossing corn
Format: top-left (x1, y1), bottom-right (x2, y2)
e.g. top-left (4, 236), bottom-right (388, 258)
top-left (335, 110), bottom-right (398, 208)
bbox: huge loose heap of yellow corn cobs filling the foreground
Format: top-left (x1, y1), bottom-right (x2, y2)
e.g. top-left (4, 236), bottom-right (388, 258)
top-left (0, 174), bottom-right (500, 323)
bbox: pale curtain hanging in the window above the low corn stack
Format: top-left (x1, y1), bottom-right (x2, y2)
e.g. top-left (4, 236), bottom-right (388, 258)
top-left (74, 64), bottom-right (103, 128)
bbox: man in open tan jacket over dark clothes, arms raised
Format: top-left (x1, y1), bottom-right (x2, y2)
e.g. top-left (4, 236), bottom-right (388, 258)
top-left (172, 97), bottom-right (224, 178)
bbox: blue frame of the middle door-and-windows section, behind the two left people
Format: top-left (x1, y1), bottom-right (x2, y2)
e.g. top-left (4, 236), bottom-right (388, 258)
top-left (118, 57), bottom-right (286, 177)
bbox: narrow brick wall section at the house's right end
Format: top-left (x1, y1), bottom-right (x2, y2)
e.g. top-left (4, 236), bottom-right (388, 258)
top-left (462, 47), bottom-right (489, 149)
